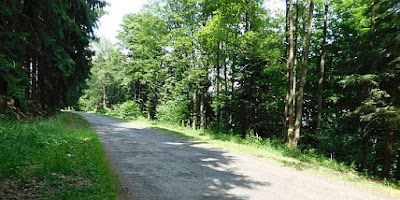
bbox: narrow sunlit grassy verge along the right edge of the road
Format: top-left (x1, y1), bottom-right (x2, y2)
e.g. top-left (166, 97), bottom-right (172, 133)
top-left (96, 111), bottom-right (400, 198)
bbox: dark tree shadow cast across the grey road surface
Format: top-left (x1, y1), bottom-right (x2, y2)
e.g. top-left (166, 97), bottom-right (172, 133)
top-left (85, 116), bottom-right (271, 199)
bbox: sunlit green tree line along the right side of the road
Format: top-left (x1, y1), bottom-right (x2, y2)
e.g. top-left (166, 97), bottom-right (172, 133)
top-left (81, 0), bottom-right (400, 179)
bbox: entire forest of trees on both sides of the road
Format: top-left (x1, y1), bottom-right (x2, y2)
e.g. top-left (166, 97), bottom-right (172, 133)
top-left (0, 0), bottom-right (400, 180)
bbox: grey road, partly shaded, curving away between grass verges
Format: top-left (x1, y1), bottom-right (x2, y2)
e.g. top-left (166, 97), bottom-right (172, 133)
top-left (79, 113), bottom-right (391, 200)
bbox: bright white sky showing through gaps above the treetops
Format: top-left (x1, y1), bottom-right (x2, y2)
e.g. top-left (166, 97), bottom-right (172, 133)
top-left (95, 0), bottom-right (285, 44)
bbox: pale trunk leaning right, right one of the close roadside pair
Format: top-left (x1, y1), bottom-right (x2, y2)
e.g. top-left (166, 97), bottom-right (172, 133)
top-left (289, 0), bottom-right (314, 148)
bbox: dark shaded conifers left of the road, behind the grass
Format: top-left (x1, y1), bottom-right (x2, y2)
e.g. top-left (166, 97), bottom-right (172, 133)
top-left (0, 0), bottom-right (105, 113)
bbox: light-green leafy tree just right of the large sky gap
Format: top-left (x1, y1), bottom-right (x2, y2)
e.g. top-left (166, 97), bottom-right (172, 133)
top-left (118, 12), bottom-right (166, 119)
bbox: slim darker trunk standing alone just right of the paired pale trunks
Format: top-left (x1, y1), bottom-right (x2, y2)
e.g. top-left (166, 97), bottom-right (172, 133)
top-left (316, 0), bottom-right (329, 136)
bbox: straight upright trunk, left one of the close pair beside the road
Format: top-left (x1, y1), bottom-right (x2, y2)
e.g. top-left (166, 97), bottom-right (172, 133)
top-left (287, 0), bottom-right (294, 147)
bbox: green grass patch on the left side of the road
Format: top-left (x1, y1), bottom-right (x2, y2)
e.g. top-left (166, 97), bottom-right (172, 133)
top-left (0, 113), bottom-right (118, 199)
